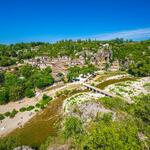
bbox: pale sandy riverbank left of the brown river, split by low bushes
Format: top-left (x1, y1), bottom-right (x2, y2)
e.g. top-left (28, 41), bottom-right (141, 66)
top-left (0, 83), bottom-right (79, 137)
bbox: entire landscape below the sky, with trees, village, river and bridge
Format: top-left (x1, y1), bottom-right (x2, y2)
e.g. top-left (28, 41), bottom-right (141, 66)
top-left (0, 39), bottom-right (150, 150)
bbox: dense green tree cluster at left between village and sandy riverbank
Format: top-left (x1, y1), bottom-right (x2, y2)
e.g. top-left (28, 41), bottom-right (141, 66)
top-left (0, 65), bottom-right (54, 104)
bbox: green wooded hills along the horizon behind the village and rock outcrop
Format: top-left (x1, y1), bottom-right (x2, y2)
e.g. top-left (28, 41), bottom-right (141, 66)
top-left (0, 39), bottom-right (150, 76)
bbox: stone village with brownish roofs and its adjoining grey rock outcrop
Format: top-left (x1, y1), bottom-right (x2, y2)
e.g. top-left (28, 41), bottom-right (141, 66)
top-left (0, 43), bottom-right (119, 82)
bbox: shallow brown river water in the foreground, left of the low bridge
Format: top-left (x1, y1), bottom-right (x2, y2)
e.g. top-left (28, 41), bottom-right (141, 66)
top-left (9, 90), bottom-right (82, 147)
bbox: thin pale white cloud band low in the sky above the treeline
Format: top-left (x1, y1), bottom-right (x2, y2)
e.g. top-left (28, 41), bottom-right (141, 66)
top-left (0, 28), bottom-right (150, 44)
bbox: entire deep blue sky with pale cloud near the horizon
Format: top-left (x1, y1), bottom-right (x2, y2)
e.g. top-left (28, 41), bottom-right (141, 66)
top-left (0, 0), bottom-right (150, 44)
